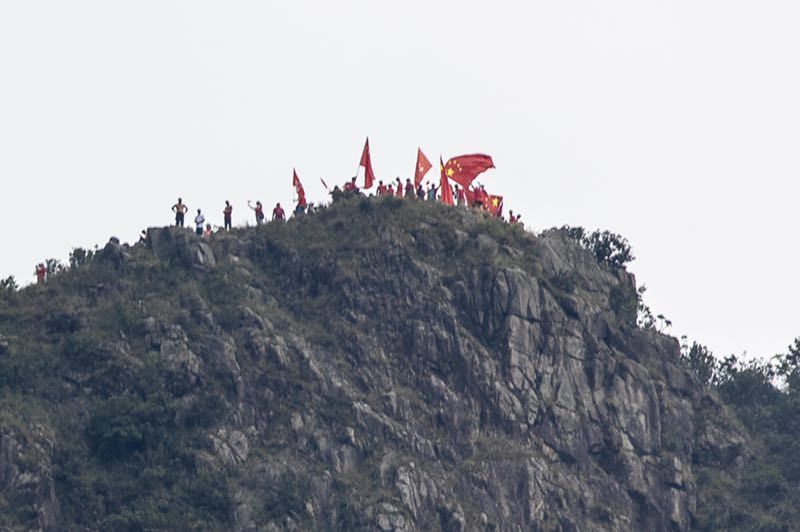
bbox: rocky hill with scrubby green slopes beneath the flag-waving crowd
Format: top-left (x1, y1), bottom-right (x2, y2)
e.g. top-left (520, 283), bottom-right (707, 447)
top-left (0, 198), bottom-right (749, 531)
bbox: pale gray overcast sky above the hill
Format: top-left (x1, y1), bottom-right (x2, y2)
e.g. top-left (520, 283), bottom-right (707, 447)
top-left (0, 0), bottom-right (800, 355)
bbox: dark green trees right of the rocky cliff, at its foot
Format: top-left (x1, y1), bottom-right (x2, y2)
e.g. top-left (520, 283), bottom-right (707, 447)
top-left (681, 338), bottom-right (800, 530)
